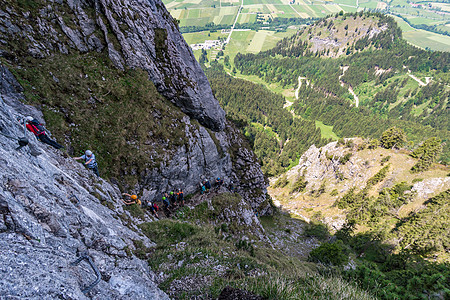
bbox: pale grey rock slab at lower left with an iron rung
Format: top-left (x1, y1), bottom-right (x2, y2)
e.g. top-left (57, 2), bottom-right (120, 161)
top-left (0, 88), bottom-right (169, 299)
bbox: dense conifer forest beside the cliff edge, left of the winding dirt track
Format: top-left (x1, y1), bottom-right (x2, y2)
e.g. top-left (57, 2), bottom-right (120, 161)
top-left (205, 63), bottom-right (327, 176)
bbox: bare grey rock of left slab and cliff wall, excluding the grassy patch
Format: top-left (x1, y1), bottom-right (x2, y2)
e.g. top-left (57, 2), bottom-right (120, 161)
top-left (0, 0), bottom-right (270, 299)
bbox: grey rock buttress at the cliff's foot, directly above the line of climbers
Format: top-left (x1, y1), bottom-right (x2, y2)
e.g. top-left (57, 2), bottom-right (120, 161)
top-left (137, 117), bottom-right (272, 214)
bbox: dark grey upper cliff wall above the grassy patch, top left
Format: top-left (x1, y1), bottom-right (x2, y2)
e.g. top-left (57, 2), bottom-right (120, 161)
top-left (0, 0), bottom-right (225, 130)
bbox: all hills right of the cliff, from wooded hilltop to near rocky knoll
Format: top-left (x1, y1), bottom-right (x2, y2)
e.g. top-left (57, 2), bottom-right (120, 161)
top-left (207, 13), bottom-right (450, 299)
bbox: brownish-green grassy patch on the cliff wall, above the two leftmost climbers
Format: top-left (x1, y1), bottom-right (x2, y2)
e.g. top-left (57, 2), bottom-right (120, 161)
top-left (10, 53), bottom-right (186, 185)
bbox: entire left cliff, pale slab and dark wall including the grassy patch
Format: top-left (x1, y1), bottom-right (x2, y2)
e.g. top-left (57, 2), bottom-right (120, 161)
top-left (0, 0), bottom-right (270, 299)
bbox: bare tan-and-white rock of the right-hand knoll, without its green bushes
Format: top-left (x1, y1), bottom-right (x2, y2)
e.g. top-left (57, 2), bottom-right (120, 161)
top-left (269, 138), bottom-right (450, 229)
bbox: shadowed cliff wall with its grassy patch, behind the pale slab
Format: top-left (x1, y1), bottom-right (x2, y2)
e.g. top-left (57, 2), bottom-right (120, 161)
top-left (0, 0), bottom-right (269, 211)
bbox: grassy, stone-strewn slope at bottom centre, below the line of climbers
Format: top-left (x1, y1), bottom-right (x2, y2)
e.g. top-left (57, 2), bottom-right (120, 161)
top-left (135, 194), bottom-right (372, 300)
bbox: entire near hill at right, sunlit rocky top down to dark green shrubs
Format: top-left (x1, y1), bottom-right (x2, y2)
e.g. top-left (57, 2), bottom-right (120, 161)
top-left (269, 138), bottom-right (450, 299)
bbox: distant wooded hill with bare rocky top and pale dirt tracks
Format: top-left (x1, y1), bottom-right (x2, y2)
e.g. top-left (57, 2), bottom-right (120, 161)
top-left (230, 13), bottom-right (450, 168)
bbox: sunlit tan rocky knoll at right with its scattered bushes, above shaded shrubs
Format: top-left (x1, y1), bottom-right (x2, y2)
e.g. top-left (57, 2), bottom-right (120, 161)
top-left (270, 138), bottom-right (450, 251)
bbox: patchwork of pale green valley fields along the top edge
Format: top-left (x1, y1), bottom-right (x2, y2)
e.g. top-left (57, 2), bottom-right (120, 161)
top-left (163, 0), bottom-right (450, 52)
